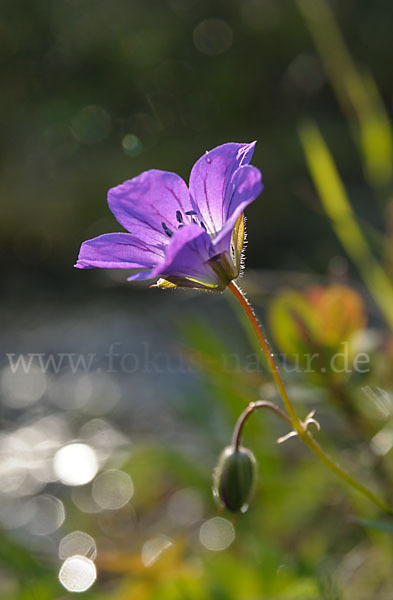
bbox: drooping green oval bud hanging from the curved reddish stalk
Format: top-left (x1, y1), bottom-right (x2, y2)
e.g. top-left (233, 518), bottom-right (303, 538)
top-left (213, 446), bottom-right (256, 512)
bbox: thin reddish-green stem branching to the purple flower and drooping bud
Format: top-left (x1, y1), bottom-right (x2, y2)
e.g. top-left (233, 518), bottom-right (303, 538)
top-left (228, 281), bottom-right (393, 515)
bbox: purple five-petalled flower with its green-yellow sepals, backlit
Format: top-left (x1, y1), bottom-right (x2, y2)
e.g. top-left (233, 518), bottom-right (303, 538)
top-left (75, 142), bottom-right (263, 290)
